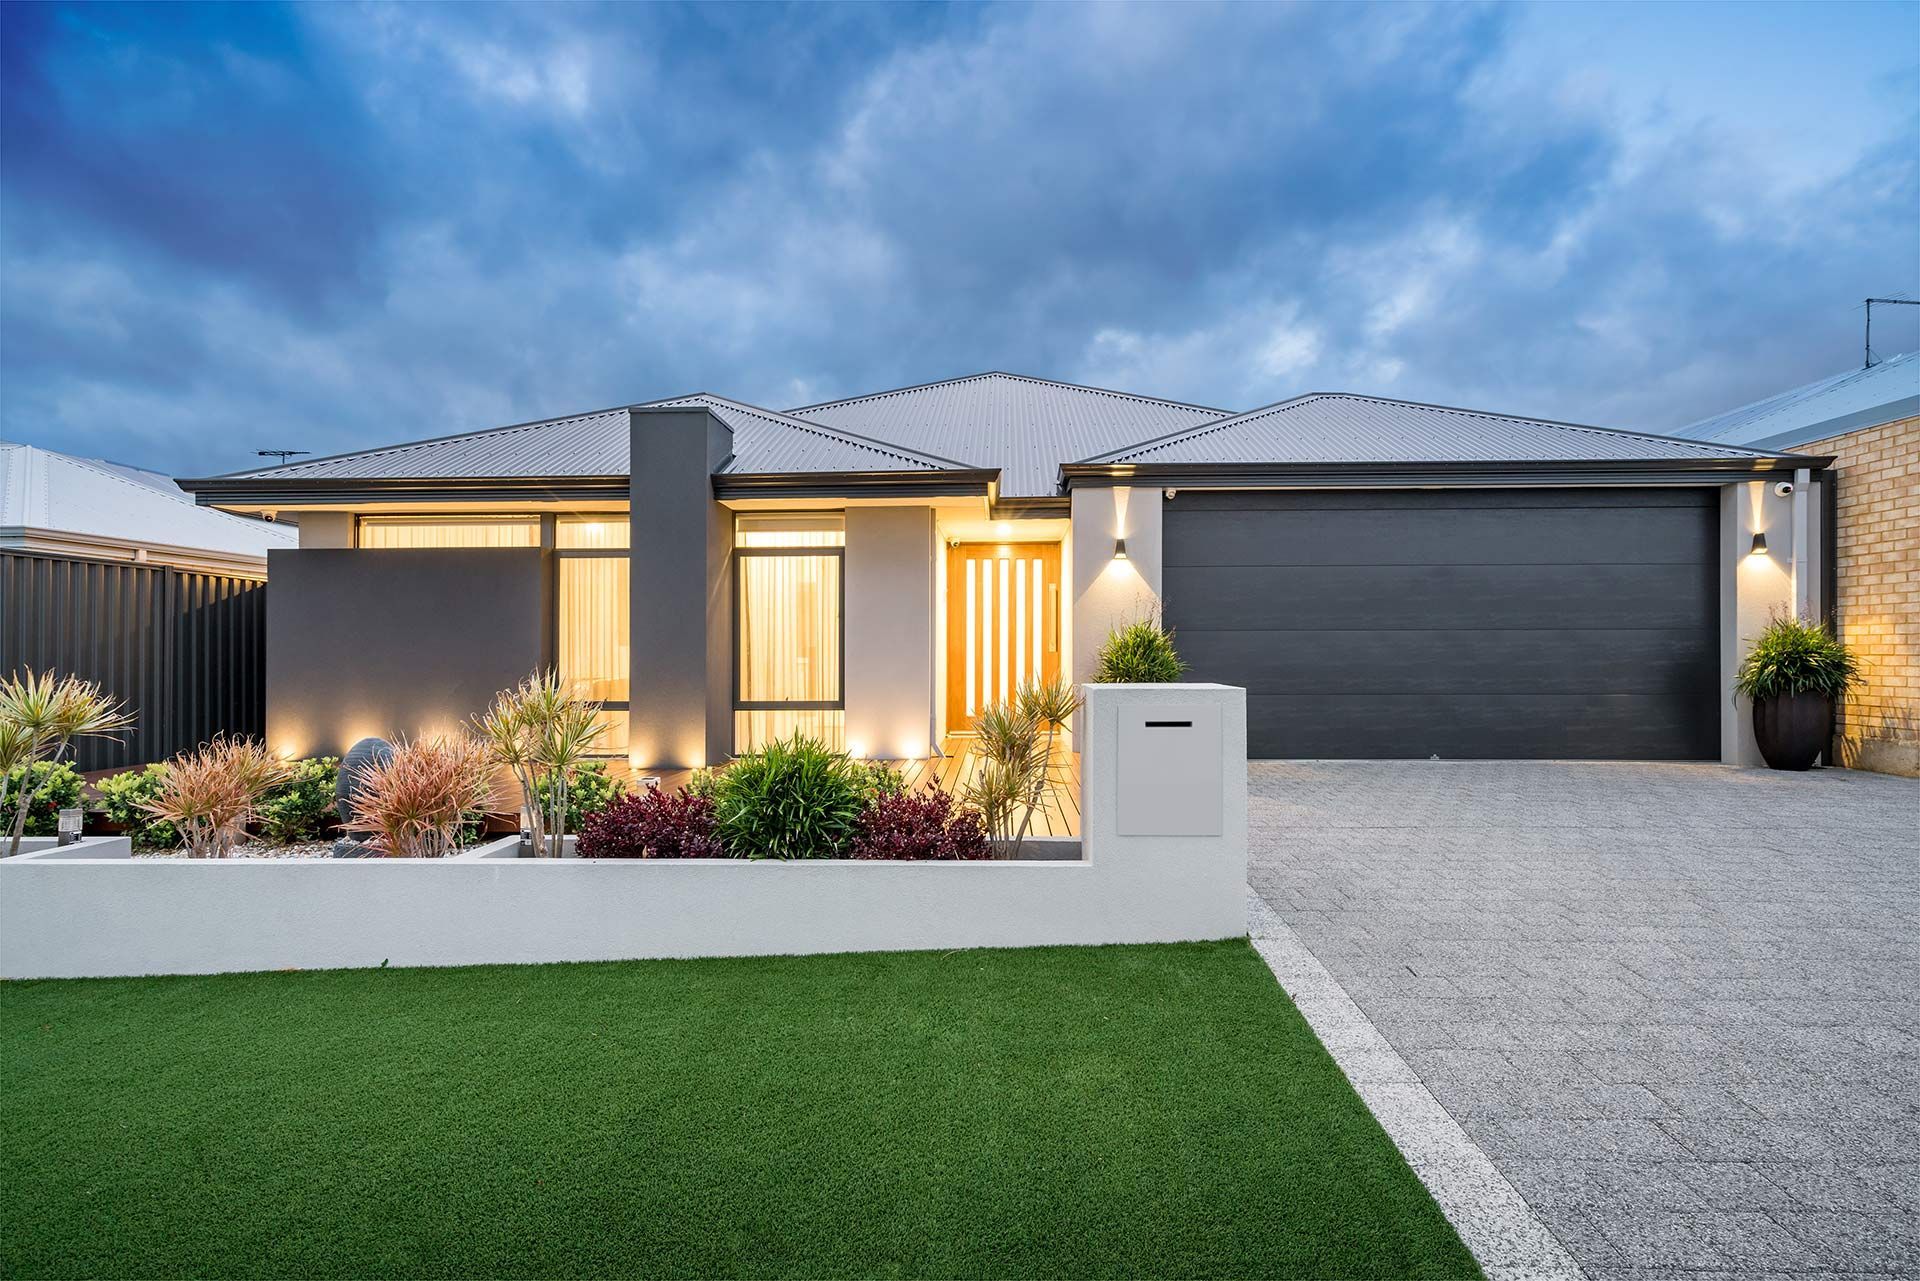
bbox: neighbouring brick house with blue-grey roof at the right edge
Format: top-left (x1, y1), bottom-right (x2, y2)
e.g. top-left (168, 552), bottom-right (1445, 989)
top-left (1678, 351), bottom-right (1920, 776)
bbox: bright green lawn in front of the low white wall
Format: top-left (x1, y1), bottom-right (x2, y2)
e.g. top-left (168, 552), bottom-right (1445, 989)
top-left (0, 941), bottom-right (1478, 1277)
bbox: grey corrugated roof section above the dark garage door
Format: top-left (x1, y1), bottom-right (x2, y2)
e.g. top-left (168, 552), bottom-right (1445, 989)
top-left (1085, 392), bottom-right (1797, 465)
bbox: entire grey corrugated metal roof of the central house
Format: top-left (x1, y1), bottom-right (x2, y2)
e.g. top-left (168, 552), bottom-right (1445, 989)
top-left (186, 373), bottom-right (1820, 501)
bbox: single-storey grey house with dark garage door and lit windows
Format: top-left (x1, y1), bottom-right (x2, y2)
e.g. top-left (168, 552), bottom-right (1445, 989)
top-left (182, 373), bottom-right (1828, 768)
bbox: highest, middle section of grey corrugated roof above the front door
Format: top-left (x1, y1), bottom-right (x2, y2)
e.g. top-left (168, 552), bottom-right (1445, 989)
top-left (787, 373), bottom-right (1225, 497)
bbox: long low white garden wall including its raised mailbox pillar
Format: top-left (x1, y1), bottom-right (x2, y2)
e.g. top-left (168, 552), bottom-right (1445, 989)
top-left (0, 686), bottom-right (1246, 978)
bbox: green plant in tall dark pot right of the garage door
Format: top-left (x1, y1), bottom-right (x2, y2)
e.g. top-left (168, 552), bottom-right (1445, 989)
top-left (1734, 616), bottom-right (1860, 770)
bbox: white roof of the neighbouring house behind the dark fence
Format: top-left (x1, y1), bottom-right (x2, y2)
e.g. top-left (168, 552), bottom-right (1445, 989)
top-left (0, 442), bottom-right (300, 574)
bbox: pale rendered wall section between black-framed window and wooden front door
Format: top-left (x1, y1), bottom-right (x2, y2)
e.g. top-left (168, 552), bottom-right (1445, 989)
top-left (843, 507), bottom-right (941, 761)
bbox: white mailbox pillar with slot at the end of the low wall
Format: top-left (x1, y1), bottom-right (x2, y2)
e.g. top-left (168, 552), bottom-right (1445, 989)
top-left (1081, 684), bottom-right (1246, 939)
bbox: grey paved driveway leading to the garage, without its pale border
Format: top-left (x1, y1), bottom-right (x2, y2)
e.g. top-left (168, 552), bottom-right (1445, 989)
top-left (1248, 762), bottom-right (1920, 1277)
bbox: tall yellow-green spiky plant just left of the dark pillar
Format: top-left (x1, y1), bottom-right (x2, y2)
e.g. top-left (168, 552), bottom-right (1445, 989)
top-left (474, 670), bottom-right (607, 857)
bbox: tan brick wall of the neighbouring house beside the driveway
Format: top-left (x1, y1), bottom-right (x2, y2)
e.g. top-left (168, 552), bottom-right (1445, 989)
top-left (1795, 419), bottom-right (1920, 776)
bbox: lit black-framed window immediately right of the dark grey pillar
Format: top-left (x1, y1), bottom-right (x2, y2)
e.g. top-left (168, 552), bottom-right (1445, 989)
top-left (733, 515), bottom-right (847, 751)
